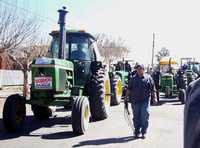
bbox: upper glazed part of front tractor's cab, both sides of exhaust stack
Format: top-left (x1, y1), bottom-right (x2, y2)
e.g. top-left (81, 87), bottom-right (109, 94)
top-left (50, 33), bottom-right (99, 61)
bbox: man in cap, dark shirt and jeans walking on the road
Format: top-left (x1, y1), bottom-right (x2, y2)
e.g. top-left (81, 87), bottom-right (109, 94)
top-left (126, 64), bottom-right (156, 139)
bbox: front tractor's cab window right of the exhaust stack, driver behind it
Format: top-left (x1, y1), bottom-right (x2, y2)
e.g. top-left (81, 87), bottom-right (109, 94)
top-left (69, 36), bottom-right (94, 61)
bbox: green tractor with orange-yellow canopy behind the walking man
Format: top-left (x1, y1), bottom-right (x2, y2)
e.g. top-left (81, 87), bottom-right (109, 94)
top-left (159, 58), bottom-right (187, 104)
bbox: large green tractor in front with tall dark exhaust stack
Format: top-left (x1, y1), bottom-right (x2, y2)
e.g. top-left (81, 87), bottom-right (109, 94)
top-left (3, 7), bottom-right (118, 134)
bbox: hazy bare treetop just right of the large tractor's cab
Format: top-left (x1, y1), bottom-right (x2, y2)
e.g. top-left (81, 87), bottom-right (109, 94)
top-left (95, 34), bottom-right (129, 62)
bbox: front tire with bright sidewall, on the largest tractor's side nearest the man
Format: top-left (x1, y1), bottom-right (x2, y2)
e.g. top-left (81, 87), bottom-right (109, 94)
top-left (72, 96), bottom-right (90, 135)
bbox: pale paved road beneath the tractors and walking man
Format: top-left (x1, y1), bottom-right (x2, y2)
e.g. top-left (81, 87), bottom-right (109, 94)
top-left (0, 96), bottom-right (183, 148)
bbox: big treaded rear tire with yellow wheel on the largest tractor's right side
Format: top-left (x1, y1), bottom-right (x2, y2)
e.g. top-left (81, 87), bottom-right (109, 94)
top-left (89, 70), bottom-right (110, 120)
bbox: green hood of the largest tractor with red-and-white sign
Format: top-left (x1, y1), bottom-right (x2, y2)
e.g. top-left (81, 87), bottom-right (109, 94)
top-left (31, 57), bottom-right (74, 92)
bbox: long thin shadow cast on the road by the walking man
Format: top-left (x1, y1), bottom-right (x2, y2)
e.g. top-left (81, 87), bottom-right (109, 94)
top-left (73, 136), bottom-right (136, 147)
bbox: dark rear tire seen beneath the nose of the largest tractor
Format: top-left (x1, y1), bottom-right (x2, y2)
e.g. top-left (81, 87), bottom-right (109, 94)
top-left (31, 105), bottom-right (52, 120)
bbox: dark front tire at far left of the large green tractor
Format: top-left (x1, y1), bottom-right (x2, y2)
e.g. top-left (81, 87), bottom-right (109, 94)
top-left (3, 94), bottom-right (26, 132)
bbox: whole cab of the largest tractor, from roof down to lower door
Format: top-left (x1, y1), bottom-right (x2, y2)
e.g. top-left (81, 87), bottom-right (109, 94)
top-left (50, 30), bottom-right (101, 86)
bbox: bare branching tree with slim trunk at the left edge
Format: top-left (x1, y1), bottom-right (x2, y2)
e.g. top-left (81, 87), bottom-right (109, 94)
top-left (0, 5), bottom-right (47, 96)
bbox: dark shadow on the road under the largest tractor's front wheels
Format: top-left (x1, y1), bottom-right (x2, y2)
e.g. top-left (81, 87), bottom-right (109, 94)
top-left (0, 116), bottom-right (76, 140)
